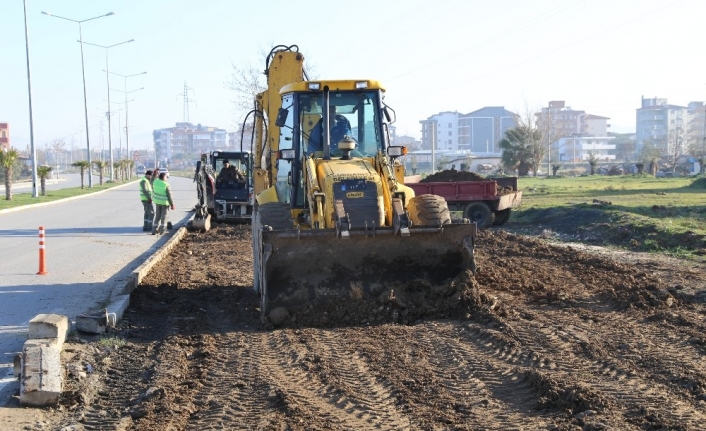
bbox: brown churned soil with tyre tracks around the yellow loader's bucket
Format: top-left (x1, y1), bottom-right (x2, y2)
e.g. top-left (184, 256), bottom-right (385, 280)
top-left (44, 226), bottom-right (706, 430)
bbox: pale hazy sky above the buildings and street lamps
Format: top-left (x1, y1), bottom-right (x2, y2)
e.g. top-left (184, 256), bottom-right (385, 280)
top-left (0, 0), bottom-right (706, 155)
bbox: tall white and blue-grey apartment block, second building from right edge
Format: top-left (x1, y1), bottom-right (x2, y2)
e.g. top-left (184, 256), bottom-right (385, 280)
top-left (635, 97), bottom-right (688, 154)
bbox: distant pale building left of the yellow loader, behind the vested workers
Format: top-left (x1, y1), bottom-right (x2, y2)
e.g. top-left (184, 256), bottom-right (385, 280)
top-left (152, 122), bottom-right (227, 161)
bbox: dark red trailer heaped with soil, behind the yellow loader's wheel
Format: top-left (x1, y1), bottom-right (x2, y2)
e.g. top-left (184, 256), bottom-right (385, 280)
top-left (405, 170), bottom-right (522, 228)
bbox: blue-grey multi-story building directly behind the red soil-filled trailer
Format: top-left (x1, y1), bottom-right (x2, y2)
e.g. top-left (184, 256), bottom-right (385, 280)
top-left (457, 106), bottom-right (519, 156)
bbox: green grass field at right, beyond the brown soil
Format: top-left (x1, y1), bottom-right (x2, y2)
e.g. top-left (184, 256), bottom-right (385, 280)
top-left (511, 176), bottom-right (706, 261)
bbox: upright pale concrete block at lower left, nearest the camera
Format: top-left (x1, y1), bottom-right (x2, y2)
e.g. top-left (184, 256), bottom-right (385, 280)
top-left (20, 338), bottom-right (63, 407)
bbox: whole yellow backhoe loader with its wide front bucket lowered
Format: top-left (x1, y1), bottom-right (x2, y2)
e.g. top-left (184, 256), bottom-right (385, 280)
top-left (252, 45), bottom-right (476, 320)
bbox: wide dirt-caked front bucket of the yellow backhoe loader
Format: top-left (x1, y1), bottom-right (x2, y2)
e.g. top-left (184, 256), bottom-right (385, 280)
top-left (253, 223), bottom-right (476, 320)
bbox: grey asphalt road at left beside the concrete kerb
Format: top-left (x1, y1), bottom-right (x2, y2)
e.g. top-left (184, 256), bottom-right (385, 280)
top-left (0, 175), bottom-right (196, 406)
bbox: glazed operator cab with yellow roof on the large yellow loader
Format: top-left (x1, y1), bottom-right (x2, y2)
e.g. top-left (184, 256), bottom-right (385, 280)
top-left (276, 80), bottom-right (392, 207)
